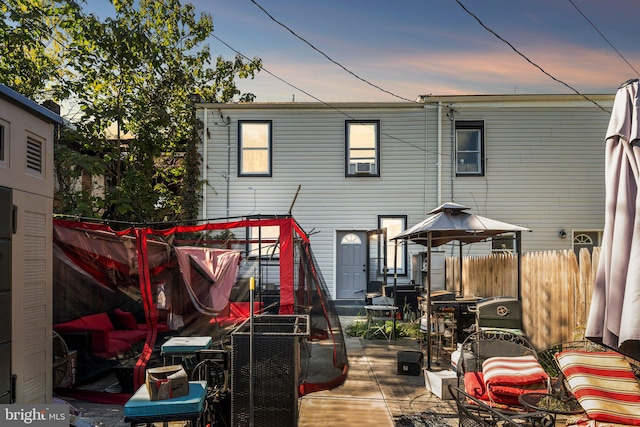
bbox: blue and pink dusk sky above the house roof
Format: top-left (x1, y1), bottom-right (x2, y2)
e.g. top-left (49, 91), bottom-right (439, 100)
top-left (87, 0), bottom-right (640, 102)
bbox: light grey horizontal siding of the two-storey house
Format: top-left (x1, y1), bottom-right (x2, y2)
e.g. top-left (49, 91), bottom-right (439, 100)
top-left (197, 95), bottom-right (613, 296)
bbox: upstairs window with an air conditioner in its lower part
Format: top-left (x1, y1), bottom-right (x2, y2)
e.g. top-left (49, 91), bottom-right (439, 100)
top-left (345, 120), bottom-right (380, 177)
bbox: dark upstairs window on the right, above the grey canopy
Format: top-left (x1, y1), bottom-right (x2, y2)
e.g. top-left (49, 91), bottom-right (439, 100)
top-left (455, 120), bottom-right (485, 176)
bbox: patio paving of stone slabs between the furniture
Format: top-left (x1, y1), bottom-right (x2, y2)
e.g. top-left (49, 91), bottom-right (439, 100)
top-left (67, 320), bottom-right (458, 427)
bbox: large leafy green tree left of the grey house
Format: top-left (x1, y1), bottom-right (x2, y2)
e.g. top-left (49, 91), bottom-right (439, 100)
top-left (2, 0), bottom-right (261, 222)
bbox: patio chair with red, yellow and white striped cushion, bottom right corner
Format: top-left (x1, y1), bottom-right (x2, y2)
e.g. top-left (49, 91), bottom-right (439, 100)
top-left (539, 340), bottom-right (640, 427)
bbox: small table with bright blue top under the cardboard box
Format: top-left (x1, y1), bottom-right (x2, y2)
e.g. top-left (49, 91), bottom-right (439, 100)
top-left (124, 381), bottom-right (207, 427)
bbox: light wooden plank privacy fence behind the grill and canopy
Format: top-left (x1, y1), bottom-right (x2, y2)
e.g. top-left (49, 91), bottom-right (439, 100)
top-left (446, 248), bottom-right (600, 350)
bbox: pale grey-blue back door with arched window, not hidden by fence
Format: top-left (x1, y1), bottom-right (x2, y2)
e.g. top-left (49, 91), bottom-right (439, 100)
top-left (335, 231), bottom-right (367, 299)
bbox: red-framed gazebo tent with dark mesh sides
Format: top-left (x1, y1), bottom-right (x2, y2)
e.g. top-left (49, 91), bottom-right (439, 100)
top-left (53, 215), bottom-right (348, 395)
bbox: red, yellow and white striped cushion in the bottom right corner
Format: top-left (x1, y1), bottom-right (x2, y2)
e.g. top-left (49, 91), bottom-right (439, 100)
top-left (556, 350), bottom-right (640, 426)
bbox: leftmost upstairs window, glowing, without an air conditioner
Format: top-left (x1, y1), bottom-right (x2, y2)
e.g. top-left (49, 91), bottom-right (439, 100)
top-left (238, 120), bottom-right (273, 176)
